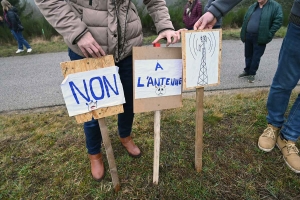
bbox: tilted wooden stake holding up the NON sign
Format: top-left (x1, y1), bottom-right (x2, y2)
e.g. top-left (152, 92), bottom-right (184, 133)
top-left (98, 118), bottom-right (120, 192)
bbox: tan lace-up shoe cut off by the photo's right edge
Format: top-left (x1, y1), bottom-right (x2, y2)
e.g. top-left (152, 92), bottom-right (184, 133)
top-left (276, 136), bottom-right (300, 173)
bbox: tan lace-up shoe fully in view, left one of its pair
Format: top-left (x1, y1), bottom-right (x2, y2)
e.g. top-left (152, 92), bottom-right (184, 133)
top-left (258, 124), bottom-right (280, 152)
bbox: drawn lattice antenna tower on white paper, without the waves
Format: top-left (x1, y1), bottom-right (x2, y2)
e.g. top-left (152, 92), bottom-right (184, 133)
top-left (197, 35), bottom-right (208, 85)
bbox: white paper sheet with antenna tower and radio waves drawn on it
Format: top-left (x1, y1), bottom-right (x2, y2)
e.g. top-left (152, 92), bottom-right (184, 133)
top-left (185, 30), bottom-right (220, 88)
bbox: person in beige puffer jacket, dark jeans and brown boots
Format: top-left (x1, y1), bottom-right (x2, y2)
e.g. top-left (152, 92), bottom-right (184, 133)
top-left (35, 0), bottom-right (180, 181)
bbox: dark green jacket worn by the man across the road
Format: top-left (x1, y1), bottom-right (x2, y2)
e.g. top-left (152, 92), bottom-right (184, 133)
top-left (241, 0), bottom-right (283, 44)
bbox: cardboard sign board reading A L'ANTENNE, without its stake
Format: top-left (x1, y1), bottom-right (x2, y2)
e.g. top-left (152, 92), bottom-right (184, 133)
top-left (133, 47), bottom-right (182, 113)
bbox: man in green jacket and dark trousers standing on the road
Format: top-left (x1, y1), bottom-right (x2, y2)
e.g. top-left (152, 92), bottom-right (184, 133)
top-left (239, 0), bottom-right (282, 83)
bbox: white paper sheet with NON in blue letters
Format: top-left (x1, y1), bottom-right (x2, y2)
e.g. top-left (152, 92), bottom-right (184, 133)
top-left (61, 66), bottom-right (125, 116)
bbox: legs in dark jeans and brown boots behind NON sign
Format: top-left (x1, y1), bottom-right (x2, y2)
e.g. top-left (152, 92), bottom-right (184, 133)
top-left (69, 49), bottom-right (141, 181)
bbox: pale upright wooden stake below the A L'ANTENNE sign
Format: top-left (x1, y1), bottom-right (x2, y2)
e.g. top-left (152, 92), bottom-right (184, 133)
top-left (153, 111), bottom-right (160, 185)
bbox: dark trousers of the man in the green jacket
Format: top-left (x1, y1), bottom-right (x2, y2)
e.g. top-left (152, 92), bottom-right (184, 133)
top-left (244, 33), bottom-right (266, 75)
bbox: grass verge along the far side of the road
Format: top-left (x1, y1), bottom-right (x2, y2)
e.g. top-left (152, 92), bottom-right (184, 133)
top-left (0, 27), bottom-right (286, 57)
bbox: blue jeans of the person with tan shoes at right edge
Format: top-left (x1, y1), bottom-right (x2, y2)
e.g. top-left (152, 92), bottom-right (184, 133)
top-left (267, 23), bottom-right (300, 141)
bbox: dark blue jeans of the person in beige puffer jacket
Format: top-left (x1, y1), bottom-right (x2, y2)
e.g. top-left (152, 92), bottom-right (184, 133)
top-left (69, 49), bottom-right (134, 155)
